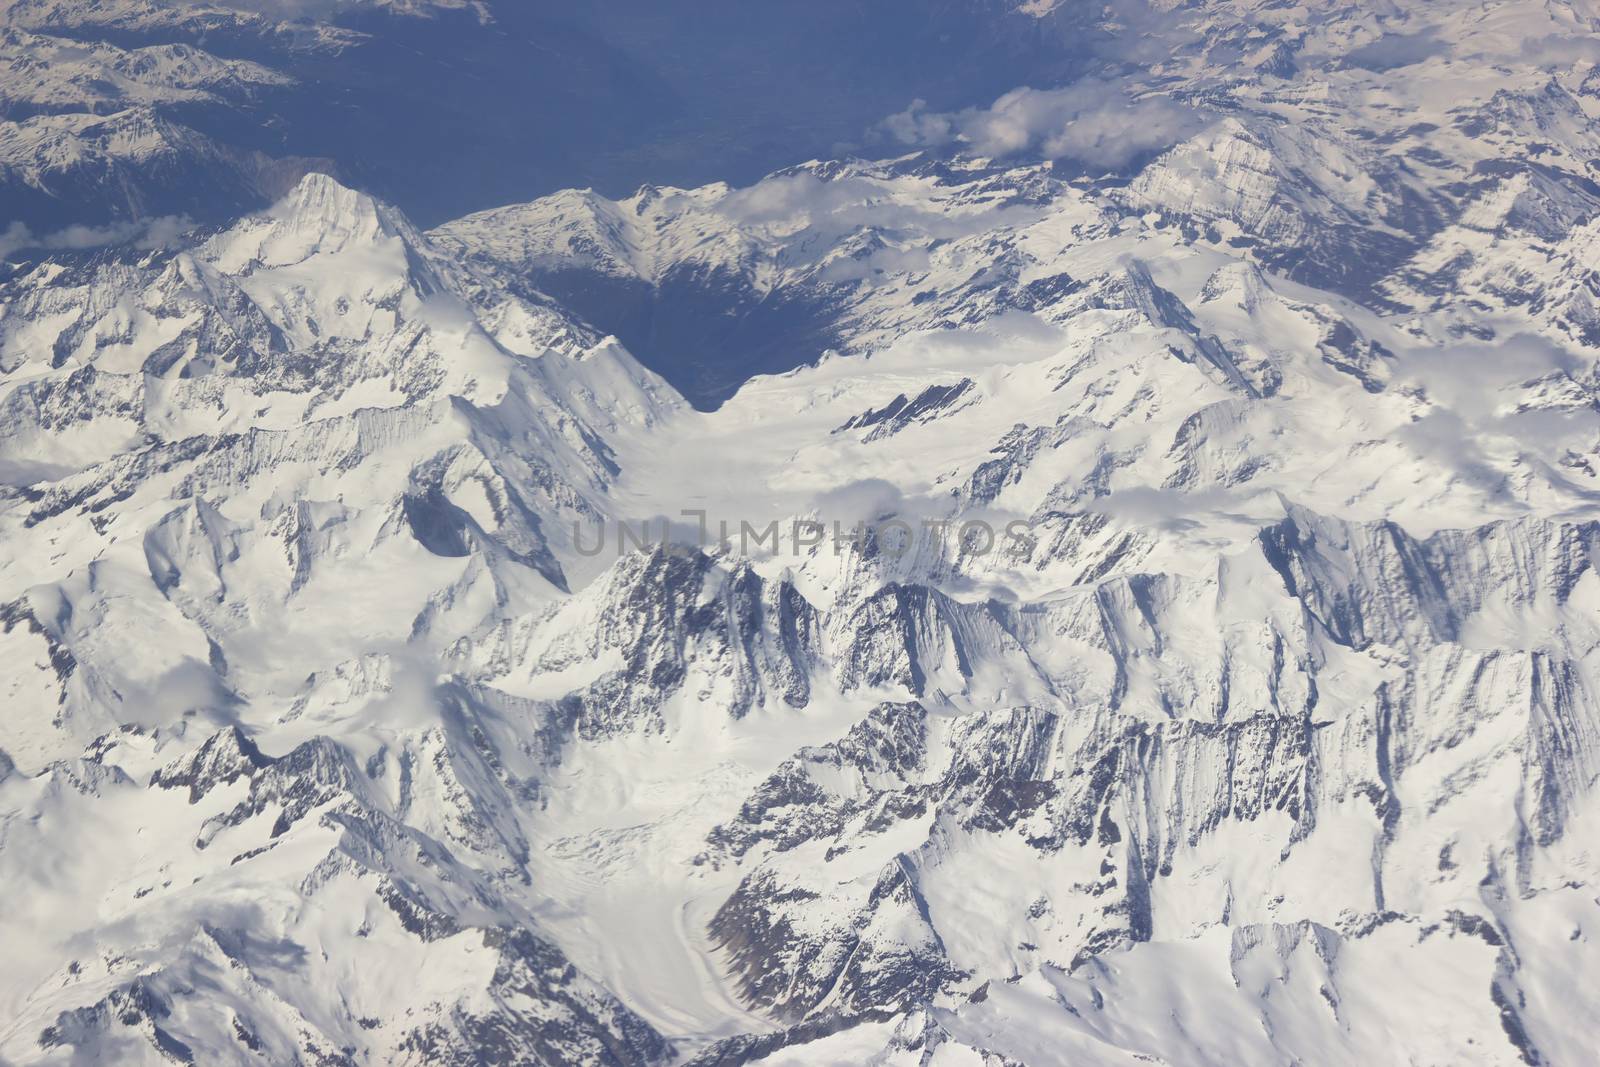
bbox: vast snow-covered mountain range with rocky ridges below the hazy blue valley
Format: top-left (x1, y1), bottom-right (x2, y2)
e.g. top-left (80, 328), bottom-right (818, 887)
top-left (9, 0), bottom-right (1600, 1067)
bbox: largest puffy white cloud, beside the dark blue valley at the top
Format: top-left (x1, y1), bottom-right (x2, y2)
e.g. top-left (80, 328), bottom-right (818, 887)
top-left (878, 78), bottom-right (1205, 171)
